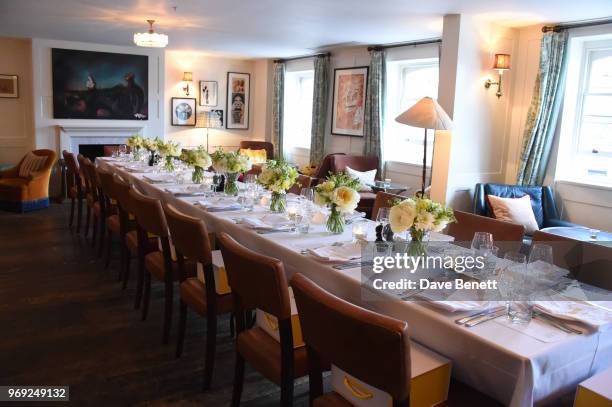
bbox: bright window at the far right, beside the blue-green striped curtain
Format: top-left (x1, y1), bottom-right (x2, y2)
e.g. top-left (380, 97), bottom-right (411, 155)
top-left (557, 40), bottom-right (612, 185)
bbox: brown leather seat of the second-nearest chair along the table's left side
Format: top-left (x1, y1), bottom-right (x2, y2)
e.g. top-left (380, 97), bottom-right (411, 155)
top-left (237, 327), bottom-right (308, 385)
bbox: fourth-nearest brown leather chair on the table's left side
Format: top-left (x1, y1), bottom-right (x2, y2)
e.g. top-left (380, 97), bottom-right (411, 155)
top-left (128, 188), bottom-right (185, 344)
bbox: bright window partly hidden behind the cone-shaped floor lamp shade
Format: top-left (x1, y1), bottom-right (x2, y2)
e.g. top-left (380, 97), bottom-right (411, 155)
top-left (383, 58), bottom-right (438, 164)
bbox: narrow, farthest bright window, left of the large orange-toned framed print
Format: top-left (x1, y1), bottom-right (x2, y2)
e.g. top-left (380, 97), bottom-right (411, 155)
top-left (283, 70), bottom-right (314, 156)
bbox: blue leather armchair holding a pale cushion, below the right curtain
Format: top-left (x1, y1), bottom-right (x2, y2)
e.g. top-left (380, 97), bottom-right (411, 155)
top-left (473, 184), bottom-right (578, 236)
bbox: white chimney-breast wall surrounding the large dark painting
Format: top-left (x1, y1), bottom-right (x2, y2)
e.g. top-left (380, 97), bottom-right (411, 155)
top-left (32, 38), bottom-right (166, 152)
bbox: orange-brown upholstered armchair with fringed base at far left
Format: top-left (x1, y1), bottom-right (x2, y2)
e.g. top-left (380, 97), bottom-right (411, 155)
top-left (0, 150), bottom-right (57, 212)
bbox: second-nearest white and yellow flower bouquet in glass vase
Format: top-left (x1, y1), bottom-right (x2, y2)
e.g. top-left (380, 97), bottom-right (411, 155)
top-left (314, 173), bottom-right (360, 234)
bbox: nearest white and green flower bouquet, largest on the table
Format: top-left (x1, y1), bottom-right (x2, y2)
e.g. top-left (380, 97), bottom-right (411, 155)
top-left (389, 198), bottom-right (457, 254)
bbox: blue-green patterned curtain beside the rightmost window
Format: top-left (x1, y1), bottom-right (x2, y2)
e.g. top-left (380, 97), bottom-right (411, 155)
top-left (516, 31), bottom-right (568, 185)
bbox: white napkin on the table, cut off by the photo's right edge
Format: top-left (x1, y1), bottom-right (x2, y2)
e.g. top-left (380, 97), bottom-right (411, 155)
top-left (535, 300), bottom-right (612, 331)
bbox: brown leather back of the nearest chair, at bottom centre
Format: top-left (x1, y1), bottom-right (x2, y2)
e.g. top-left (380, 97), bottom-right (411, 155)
top-left (291, 273), bottom-right (411, 405)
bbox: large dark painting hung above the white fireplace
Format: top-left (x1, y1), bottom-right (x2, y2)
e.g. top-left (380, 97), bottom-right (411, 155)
top-left (51, 48), bottom-right (149, 120)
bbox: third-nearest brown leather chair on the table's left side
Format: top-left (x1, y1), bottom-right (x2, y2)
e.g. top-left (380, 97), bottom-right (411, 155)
top-left (164, 204), bottom-right (233, 389)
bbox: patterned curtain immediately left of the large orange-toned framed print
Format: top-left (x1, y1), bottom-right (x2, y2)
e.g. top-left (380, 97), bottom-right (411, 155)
top-left (310, 55), bottom-right (330, 165)
